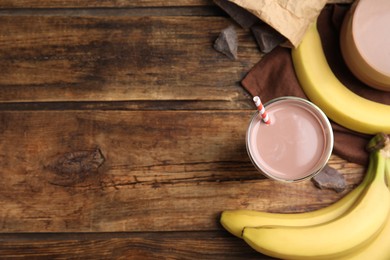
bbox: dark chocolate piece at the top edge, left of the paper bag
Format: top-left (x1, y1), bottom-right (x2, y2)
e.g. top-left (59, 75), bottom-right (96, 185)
top-left (214, 0), bottom-right (260, 29)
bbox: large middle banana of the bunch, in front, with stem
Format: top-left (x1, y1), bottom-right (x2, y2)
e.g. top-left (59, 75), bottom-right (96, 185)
top-left (243, 150), bottom-right (390, 259)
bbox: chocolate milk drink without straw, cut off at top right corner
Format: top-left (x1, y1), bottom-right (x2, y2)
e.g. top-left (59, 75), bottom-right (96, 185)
top-left (340, 0), bottom-right (390, 91)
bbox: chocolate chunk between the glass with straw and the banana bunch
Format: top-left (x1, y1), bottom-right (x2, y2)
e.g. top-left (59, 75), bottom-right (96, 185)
top-left (311, 165), bottom-right (346, 192)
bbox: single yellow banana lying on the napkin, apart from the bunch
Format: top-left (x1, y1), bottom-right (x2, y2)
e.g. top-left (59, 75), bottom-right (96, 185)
top-left (292, 23), bottom-right (390, 134)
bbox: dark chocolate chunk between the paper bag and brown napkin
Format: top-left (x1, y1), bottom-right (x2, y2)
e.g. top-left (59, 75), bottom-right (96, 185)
top-left (251, 23), bottom-right (286, 53)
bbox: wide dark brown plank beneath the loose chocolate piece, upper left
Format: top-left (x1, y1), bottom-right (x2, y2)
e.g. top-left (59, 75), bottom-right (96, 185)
top-left (0, 16), bottom-right (261, 102)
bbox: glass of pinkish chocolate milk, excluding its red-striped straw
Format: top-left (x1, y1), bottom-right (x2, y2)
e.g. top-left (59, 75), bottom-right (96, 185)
top-left (246, 97), bottom-right (333, 182)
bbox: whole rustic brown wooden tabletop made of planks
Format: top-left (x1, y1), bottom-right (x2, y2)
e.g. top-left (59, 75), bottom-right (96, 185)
top-left (0, 0), bottom-right (364, 259)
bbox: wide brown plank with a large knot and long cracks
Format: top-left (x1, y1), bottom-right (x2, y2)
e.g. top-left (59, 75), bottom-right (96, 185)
top-left (0, 110), bottom-right (362, 232)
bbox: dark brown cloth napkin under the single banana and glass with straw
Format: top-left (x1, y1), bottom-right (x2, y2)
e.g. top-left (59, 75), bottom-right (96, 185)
top-left (241, 5), bottom-right (390, 165)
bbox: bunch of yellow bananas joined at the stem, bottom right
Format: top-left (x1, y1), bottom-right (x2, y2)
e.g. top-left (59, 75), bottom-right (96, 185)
top-left (221, 134), bottom-right (390, 260)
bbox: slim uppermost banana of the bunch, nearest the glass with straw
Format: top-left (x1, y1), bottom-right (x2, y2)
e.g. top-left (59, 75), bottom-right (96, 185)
top-left (220, 164), bottom-right (375, 237)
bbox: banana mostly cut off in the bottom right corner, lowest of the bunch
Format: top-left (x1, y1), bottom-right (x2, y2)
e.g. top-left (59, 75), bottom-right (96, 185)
top-left (339, 159), bottom-right (390, 260)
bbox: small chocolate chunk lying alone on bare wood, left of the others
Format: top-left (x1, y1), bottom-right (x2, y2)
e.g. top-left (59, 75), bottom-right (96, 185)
top-left (213, 26), bottom-right (238, 60)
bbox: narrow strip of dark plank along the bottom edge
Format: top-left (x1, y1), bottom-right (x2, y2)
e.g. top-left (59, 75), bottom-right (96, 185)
top-left (0, 232), bottom-right (274, 260)
